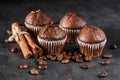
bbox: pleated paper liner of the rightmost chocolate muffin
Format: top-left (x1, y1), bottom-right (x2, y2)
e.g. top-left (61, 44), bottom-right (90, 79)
top-left (77, 38), bottom-right (107, 58)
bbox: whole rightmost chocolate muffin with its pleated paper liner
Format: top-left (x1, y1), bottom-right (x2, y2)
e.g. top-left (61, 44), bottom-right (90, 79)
top-left (77, 26), bottom-right (107, 58)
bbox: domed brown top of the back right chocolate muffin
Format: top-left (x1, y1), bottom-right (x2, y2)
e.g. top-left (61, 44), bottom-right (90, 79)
top-left (60, 12), bottom-right (86, 29)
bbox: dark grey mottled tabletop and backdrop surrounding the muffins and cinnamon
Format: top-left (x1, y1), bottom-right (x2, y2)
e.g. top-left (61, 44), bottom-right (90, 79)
top-left (0, 0), bottom-right (120, 80)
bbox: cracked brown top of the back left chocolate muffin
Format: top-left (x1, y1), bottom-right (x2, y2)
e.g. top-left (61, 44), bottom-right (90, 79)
top-left (25, 10), bottom-right (53, 26)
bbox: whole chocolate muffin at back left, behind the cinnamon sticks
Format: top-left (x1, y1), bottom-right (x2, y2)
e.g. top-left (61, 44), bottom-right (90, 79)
top-left (25, 10), bottom-right (53, 35)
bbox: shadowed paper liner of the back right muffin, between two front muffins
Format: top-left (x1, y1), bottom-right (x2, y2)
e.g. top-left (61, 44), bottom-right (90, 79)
top-left (59, 25), bottom-right (80, 44)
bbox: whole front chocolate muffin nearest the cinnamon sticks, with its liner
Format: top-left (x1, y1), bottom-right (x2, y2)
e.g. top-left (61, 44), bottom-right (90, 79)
top-left (37, 24), bottom-right (67, 54)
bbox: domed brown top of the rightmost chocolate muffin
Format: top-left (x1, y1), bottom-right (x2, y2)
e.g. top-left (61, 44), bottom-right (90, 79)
top-left (78, 26), bottom-right (106, 44)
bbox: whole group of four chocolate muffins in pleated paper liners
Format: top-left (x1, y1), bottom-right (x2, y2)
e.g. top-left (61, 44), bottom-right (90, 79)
top-left (25, 10), bottom-right (107, 58)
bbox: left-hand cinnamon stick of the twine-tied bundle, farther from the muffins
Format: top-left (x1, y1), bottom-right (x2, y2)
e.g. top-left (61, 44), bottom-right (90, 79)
top-left (12, 22), bottom-right (32, 59)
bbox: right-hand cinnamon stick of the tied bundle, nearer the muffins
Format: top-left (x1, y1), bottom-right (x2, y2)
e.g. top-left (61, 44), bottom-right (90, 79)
top-left (24, 34), bottom-right (43, 58)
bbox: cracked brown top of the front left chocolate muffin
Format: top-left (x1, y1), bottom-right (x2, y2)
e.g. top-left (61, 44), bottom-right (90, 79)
top-left (38, 24), bottom-right (67, 41)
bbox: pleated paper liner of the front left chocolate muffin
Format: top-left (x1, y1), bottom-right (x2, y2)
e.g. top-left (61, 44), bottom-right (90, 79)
top-left (37, 36), bottom-right (67, 55)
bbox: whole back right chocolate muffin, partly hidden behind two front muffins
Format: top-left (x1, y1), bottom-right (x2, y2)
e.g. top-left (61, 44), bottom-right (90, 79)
top-left (59, 12), bottom-right (86, 43)
